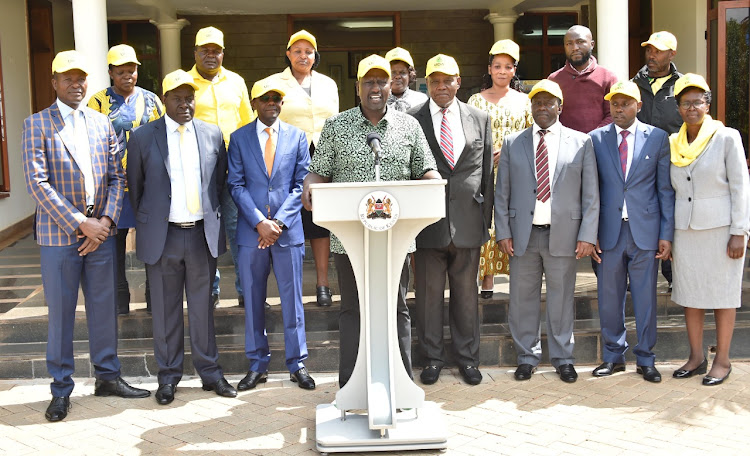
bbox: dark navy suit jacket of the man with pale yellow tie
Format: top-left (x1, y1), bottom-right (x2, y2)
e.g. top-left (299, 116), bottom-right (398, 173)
top-left (128, 117), bottom-right (227, 264)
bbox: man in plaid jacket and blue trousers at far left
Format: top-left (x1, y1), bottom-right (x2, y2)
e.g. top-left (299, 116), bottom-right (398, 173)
top-left (22, 51), bottom-right (151, 421)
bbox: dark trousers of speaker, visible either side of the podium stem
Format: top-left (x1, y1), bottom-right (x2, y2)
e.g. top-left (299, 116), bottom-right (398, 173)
top-left (333, 253), bottom-right (414, 388)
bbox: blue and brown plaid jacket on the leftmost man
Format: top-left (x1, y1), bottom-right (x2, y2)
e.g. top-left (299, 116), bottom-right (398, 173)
top-left (22, 102), bottom-right (125, 246)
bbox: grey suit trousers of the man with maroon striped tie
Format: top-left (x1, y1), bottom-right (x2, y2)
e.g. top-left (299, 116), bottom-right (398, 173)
top-left (508, 226), bottom-right (577, 367)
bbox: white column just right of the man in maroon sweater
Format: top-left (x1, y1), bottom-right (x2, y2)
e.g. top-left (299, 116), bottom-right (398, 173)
top-left (594, 0), bottom-right (630, 81)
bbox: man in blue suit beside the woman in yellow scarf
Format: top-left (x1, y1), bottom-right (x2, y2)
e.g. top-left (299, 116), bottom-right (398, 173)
top-left (590, 81), bottom-right (674, 383)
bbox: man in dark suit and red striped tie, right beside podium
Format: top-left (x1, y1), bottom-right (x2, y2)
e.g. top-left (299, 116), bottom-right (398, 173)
top-left (409, 54), bottom-right (493, 385)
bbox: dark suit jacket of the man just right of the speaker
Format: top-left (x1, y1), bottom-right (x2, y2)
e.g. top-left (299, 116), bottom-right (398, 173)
top-left (409, 98), bottom-right (493, 248)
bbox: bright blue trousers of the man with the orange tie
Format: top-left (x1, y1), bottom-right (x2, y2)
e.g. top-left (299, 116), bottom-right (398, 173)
top-left (237, 244), bottom-right (307, 373)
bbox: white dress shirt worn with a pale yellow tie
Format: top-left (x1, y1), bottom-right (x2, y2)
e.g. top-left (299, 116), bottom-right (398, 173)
top-left (164, 115), bottom-right (203, 223)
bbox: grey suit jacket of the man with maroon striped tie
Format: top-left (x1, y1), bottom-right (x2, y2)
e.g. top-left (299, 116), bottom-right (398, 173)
top-left (495, 125), bottom-right (599, 256)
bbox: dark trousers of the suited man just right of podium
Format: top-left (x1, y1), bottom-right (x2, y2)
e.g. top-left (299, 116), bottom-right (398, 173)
top-left (414, 242), bottom-right (481, 367)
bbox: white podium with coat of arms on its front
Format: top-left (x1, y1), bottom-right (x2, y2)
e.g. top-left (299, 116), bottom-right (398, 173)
top-left (310, 179), bottom-right (447, 453)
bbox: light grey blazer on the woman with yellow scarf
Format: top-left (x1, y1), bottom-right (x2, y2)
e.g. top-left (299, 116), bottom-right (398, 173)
top-left (670, 127), bottom-right (750, 236)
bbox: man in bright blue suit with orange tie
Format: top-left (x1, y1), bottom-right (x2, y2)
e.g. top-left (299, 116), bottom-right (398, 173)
top-left (228, 78), bottom-right (315, 391)
